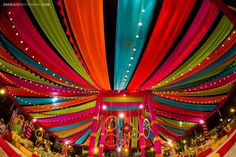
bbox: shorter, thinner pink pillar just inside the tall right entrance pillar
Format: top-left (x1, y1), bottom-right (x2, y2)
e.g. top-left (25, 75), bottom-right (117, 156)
top-left (138, 115), bottom-right (146, 157)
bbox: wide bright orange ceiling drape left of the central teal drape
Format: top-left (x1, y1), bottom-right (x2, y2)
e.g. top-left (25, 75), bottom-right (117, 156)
top-left (64, 0), bottom-right (110, 90)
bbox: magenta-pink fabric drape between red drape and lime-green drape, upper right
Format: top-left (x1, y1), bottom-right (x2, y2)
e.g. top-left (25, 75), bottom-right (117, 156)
top-left (142, 1), bottom-right (219, 89)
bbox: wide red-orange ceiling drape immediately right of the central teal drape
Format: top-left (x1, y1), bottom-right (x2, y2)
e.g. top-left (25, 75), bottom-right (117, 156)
top-left (128, 0), bottom-right (195, 90)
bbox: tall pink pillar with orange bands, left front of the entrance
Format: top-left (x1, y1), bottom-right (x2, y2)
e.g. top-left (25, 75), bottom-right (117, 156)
top-left (89, 93), bottom-right (102, 157)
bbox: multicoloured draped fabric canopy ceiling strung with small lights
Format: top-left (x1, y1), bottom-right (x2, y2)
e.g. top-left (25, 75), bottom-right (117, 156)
top-left (0, 0), bottom-right (236, 150)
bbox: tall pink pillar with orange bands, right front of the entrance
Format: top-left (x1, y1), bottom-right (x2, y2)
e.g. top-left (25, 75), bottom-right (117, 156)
top-left (146, 94), bottom-right (162, 157)
